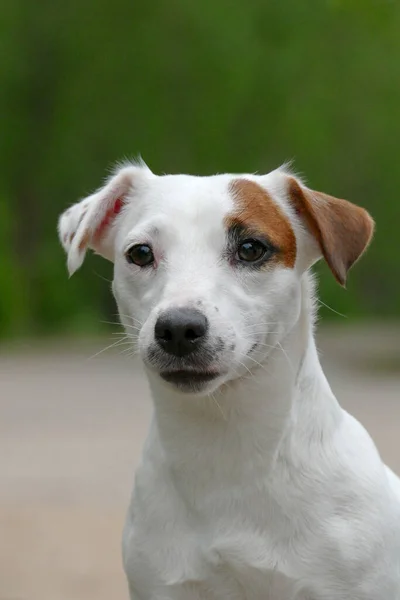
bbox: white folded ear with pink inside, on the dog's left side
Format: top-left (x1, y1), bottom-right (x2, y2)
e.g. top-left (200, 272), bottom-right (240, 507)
top-left (58, 164), bottom-right (151, 275)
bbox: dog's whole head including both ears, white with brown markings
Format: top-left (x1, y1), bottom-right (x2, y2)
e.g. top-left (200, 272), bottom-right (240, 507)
top-left (59, 164), bottom-right (373, 393)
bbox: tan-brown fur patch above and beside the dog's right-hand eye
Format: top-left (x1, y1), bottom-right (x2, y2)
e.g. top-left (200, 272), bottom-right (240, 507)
top-left (227, 179), bottom-right (296, 268)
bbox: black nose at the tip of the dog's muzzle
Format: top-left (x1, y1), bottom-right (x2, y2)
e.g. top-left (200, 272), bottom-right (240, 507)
top-left (154, 308), bottom-right (208, 356)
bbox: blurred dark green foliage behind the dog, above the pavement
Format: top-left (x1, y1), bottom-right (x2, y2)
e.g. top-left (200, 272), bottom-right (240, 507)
top-left (0, 0), bottom-right (400, 336)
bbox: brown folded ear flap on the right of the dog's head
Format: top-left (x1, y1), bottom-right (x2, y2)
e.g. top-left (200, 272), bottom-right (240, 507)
top-left (289, 177), bottom-right (374, 286)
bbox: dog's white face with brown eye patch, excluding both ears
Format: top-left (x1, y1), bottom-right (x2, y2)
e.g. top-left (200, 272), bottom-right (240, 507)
top-left (113, 176), bottom-right (299, 391)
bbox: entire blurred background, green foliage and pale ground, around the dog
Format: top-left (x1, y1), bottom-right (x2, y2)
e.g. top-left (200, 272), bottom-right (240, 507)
top-left (0, 0), bottom-right (400, 600)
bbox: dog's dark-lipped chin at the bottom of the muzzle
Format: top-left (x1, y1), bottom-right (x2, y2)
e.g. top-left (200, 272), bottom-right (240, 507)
top-left (159, 369), bottom-right (223, 395)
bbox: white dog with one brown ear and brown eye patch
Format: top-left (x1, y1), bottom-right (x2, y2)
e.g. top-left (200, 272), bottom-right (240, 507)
top-left (58, 162), bottom-right (400, 600)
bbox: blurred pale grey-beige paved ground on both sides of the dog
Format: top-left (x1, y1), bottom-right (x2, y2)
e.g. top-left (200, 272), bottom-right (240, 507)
top-left (0, 327), bottom-right (400, 600)
